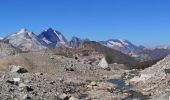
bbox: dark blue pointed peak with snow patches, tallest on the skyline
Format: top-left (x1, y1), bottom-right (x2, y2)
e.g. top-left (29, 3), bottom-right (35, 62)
top-left (38, 28), bottom-right (68, 48)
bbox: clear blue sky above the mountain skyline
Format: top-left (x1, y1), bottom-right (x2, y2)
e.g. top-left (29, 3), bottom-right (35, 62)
top-left (0, 0), bottom-right (170, 46)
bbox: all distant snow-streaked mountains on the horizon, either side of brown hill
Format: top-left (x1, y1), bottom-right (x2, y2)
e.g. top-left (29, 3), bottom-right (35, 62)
top-left (0, 28), bottom-right (170, 61)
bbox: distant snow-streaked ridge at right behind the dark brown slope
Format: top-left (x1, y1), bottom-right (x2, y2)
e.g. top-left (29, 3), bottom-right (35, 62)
top-left (99, 39), bottom-right (170, 61)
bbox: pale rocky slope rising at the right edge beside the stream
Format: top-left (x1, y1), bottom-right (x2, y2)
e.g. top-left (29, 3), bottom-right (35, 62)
top-left (130, 56), bottom-right (170, 100)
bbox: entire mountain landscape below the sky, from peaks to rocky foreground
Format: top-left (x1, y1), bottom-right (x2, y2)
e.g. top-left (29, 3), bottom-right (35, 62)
top-left (0, 28), bottom-right (170, 100)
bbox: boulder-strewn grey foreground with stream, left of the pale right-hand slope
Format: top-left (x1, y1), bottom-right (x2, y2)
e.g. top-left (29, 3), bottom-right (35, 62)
top-left (0, 67), bottom-right (147, 100)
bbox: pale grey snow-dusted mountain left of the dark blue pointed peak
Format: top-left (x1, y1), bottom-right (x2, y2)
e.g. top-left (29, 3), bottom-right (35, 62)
top-left (3, 29), bottom-right (46, 51)
